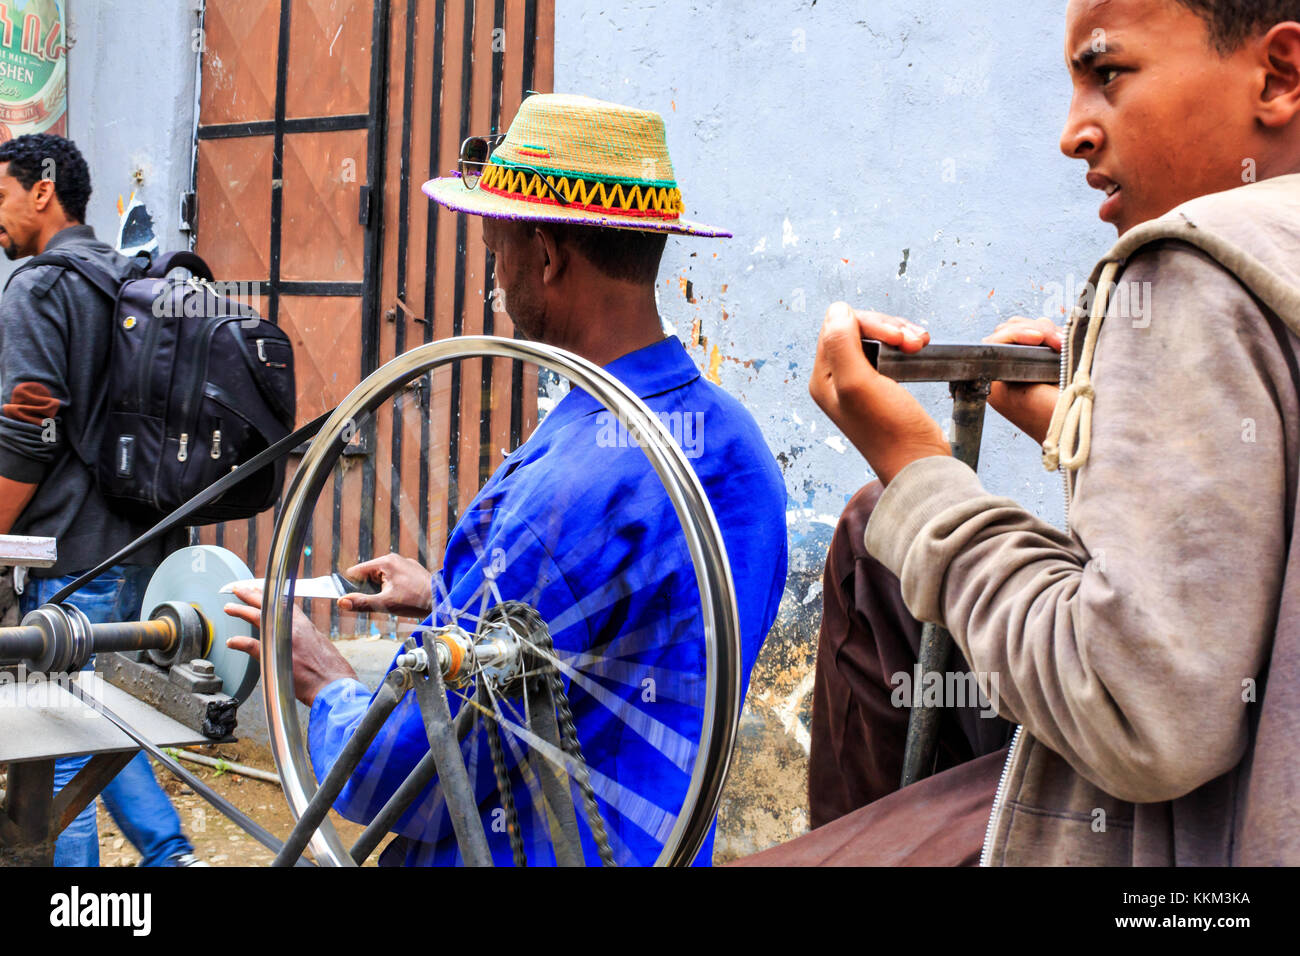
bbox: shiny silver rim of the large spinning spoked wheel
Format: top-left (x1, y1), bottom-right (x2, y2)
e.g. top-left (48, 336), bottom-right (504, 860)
top-left (261, 336), bottom-right (741, 865)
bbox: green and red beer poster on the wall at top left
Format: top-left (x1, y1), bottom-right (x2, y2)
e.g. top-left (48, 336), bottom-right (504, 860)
top-left (0, 0), bottom-right (68, 142)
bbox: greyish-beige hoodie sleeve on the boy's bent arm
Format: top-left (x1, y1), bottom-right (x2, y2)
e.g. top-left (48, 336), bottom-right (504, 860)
top-left (866, 235), bottom-right (1300, 803)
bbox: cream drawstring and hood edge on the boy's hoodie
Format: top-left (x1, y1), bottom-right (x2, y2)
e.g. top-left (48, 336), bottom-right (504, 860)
top-left (1043, 213), bottom-right (1300, 471)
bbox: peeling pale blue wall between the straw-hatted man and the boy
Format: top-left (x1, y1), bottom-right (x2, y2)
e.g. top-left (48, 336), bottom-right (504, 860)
top-left (555, 0), bottom-right (1113, 856)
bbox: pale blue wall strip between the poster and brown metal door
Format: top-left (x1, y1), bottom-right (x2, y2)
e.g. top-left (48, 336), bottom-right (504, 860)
top-left (0, 0), bottom-right (199, 290)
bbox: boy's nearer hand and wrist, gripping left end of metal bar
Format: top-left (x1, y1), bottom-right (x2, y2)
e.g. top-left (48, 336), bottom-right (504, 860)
top-left (809, 302), bottom-right (953, 485)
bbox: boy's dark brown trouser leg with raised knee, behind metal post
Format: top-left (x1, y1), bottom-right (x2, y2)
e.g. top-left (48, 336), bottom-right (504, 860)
top-left (809, 481), bottom-right (1011, 827)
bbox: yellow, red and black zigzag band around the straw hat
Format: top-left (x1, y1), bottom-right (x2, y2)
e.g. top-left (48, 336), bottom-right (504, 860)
top-left (478, 163), bottom-right (685, 220)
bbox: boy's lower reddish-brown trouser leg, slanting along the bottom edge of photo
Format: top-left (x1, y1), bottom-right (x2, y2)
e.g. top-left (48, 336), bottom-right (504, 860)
top-left (733, 748), bottom-right (1006, 866)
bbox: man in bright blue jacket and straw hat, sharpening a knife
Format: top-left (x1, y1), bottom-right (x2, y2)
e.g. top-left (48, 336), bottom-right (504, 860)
top-left (230, 95), bottom-right (787, 865)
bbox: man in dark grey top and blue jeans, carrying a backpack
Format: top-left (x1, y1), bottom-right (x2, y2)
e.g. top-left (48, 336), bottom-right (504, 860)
top-left (0, 134), bottom-right (196, 866)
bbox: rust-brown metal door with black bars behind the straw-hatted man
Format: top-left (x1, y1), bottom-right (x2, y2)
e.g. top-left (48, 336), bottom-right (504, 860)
top-left (195, 0), bottom-right (554, 633)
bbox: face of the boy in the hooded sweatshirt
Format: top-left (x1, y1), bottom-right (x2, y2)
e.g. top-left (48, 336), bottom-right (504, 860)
top-left (1061, 0), bottom-right (1262, 234)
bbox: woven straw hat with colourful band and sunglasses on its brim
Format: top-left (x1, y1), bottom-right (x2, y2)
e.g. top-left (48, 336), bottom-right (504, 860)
top-left (424, 94), bottom-right (731, 238)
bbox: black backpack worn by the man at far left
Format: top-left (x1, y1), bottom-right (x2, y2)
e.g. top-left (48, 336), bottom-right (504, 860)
top-left (10, 250), bottom-right (296, 524)
